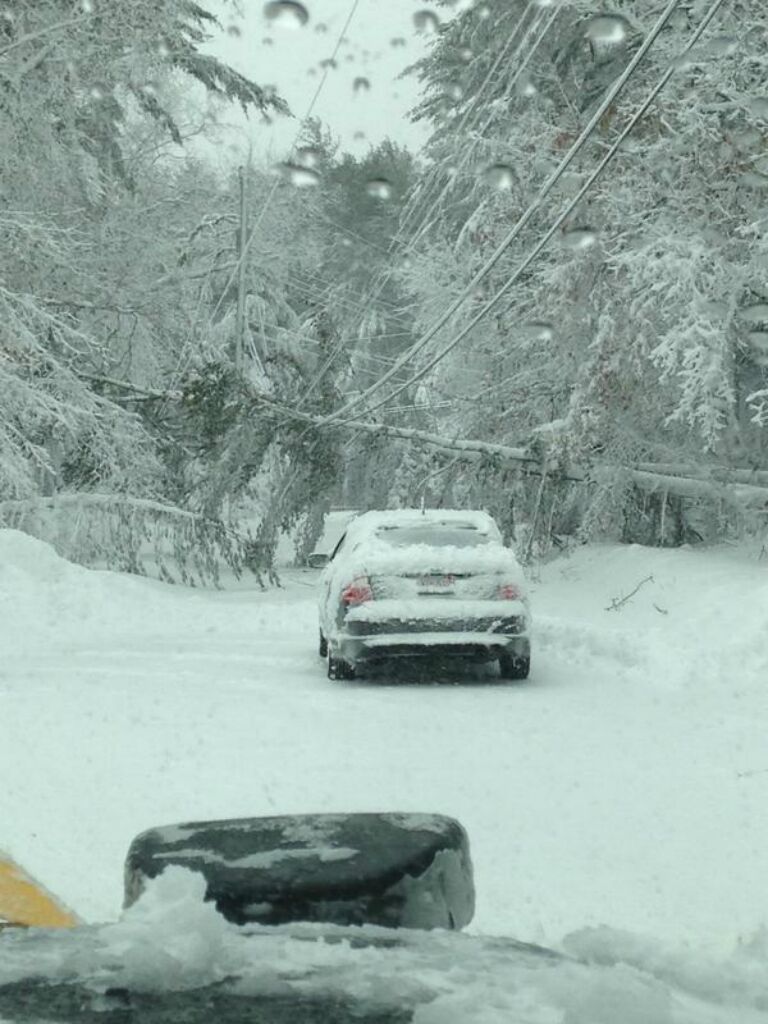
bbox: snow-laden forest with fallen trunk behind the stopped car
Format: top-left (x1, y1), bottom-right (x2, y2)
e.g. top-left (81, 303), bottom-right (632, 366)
top-left (0, 0), bottom-right (768, 583)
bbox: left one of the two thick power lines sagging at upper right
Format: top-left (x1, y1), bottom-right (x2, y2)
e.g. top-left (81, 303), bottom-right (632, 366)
top-left (319, 0), bottom-right (692, 422)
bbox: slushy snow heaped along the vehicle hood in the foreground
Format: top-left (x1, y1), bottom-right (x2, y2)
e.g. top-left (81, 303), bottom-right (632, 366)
top-left (0, 867), bottom-right (768, 1024)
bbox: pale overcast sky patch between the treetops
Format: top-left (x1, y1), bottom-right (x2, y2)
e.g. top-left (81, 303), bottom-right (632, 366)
top-left (204, 0), bottom-right (445, 160)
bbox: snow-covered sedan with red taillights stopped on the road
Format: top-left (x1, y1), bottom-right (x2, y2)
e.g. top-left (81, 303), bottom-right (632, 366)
top-left (319, 509), bottom-right (530, 679)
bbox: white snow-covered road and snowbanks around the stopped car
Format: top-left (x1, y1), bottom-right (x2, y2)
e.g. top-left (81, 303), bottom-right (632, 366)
top-left (0, 531), bottom-right (768, 1021)
